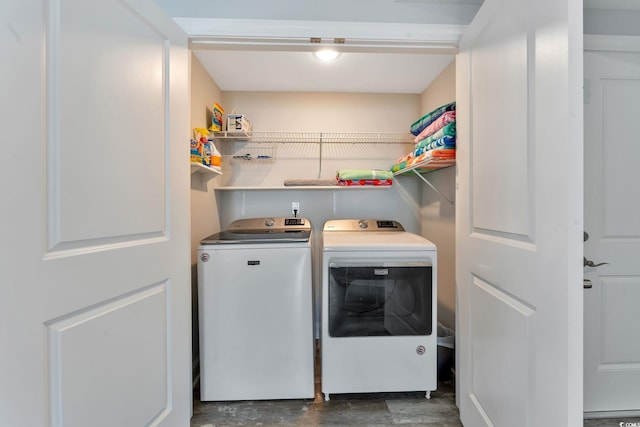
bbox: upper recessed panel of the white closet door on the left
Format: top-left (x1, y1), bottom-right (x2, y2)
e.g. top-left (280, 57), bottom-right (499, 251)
top-left (46, 0), bottom-right (169, 251)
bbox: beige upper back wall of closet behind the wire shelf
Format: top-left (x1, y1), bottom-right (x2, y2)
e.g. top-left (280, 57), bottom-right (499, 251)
top-left (218, 92), bottom-right (420, 186)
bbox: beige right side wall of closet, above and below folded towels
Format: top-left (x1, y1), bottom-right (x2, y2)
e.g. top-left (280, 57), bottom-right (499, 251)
top-left (420, 60), bottom-right (456, 328)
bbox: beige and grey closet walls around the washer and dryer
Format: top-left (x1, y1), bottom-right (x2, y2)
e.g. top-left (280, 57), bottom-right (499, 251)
top-left (185, 50), bottom-right (455, 364)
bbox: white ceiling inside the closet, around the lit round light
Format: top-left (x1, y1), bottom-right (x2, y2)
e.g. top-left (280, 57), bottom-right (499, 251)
top-left (195, 50), bottom-right (453, 93)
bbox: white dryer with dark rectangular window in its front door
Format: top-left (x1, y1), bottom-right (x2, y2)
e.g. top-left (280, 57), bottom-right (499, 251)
top-left (321, 219), bottom-right (437, 400)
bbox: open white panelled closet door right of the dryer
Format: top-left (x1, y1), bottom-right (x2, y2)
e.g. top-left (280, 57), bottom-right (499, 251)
top-left (456, 0), bottom-right (583, 427)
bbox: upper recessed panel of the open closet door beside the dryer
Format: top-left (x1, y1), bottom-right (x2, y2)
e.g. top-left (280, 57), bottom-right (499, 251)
top-left (470, 1), bottom-right (533, 237)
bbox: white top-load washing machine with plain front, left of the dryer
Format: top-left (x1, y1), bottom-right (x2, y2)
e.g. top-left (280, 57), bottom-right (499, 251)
top-left (198, 218), bottom-right (315, 401)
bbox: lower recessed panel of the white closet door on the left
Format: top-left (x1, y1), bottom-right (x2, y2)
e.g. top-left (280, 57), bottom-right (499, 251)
top-left (46, 284), bottom-right (171, 427)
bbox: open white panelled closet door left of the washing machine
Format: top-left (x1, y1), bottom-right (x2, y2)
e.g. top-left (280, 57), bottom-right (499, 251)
top-left (0, 0), bottom-right (191, 427)
